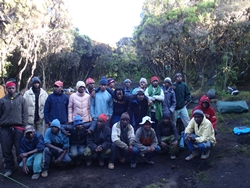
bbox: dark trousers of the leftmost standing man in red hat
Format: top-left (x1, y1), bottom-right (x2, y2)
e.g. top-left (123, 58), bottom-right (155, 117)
top-left (0, 127), bottom-right (23, 170)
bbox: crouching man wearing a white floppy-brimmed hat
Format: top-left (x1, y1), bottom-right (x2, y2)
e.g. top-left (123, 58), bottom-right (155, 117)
top-left (133, 116), bottom-right (161, 168)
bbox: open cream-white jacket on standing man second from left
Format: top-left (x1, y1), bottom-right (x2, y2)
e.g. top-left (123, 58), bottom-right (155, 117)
top-left (23, 87), bottom-right (48, 125)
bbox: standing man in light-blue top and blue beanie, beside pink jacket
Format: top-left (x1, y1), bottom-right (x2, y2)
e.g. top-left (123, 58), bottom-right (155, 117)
top-left (90, 76), bottom-right (113, 126)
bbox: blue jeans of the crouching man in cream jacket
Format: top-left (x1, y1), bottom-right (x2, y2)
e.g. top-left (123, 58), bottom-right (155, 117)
top-left (184, 134), bottom-right (212, 152)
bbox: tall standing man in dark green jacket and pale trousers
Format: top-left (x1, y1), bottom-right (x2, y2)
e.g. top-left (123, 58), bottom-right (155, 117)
top-left (172, 73), bottom-right (191, 127)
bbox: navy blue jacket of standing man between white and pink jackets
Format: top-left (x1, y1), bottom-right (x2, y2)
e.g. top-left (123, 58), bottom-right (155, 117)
top-left (44, 92), bottom-right (69, 124)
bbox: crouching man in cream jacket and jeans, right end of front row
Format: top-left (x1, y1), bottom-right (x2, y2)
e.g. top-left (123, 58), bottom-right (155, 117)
top-left (185, 110), bottom-right (216, 161)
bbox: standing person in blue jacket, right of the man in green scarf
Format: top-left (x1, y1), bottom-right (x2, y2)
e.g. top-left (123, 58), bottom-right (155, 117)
top-left (162, 77), bottom-right (176, 121)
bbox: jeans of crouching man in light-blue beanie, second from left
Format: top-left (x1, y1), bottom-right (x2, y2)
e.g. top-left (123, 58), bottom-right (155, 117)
top-left (43, 147), bottom-right (71, 170)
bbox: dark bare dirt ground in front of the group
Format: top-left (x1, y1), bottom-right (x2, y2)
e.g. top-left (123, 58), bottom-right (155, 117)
top-left (0, 101), bottom-right (250, 188)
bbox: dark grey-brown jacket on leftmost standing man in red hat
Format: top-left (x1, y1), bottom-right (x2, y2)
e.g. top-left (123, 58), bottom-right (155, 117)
top-left (0, 93), bottom-right (28, 127)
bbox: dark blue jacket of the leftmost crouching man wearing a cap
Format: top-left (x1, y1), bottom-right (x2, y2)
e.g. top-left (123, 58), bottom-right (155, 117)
top-left (20, 132), bottom-right (45, 153)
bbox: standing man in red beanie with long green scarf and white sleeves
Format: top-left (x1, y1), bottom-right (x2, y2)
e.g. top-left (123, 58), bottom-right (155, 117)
top-left (145, 76), bottom-right (164, 130)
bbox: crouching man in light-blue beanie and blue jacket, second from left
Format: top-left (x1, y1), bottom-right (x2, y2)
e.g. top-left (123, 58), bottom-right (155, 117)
top-left (42, 119), bottom-right (71, 178)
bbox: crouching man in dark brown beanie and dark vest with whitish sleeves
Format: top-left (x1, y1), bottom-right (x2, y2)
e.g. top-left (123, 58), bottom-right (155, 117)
top-left (108, 112), bottom-right (137, 170)
